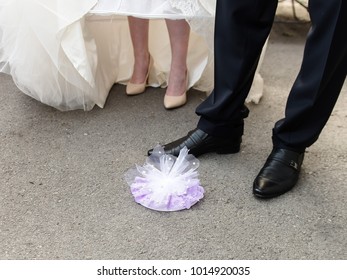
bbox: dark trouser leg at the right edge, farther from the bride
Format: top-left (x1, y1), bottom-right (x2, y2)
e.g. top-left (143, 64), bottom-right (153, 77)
top-left (273, 0), bottom-right (347, 151)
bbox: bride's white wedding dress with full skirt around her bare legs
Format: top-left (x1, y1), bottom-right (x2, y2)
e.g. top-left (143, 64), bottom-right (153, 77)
top-left (0, 0), bottom-right (262, 110)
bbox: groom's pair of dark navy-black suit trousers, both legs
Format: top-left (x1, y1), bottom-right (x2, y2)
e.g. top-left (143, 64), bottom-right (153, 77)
top-left (196, 0), bottom-right (347, 151)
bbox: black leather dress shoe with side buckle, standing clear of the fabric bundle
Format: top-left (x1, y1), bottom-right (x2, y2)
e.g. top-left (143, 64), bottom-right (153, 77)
top-left (253, 148), bottom-right (304, 198)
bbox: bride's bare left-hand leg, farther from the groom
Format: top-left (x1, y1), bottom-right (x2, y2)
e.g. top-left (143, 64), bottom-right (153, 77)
top-left (128, 16), bottom-right (150, 84)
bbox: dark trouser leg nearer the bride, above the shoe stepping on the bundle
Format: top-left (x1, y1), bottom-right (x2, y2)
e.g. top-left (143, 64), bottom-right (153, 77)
top-left (196, 0), bottom-right (277, 137)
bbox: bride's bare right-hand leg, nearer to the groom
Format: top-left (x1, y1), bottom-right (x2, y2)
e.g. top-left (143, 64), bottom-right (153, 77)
top-left (166, 19), bottom-right (190, 96)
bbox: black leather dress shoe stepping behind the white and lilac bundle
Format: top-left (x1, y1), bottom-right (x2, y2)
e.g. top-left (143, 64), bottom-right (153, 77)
top-left (148, 128), bottom-right (242, 157)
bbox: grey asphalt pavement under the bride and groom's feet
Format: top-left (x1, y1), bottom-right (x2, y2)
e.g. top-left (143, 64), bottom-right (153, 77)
top-left (0, 23), bottom-right (347, 259)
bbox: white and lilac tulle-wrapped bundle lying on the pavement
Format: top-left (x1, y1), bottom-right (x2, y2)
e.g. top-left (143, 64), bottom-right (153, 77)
top-left (125, 146), bottom-right (204, 211)
